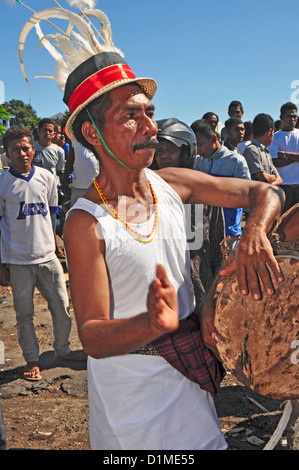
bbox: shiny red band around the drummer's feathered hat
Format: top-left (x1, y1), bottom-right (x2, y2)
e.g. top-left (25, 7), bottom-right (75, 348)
top-left (68, 64), bottom-right (136, 113)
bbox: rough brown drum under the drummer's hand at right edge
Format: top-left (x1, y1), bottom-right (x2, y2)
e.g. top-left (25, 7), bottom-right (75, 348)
top-left (215, 257), bottom-right (299, 400)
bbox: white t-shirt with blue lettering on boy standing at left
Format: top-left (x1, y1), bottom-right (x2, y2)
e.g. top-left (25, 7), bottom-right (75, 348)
top-left (0, 166), bottom-right (58, 264)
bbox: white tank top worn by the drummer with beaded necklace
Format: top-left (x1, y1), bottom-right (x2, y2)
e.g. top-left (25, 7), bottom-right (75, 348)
top-left (71, 169), bottom-right (195, 319)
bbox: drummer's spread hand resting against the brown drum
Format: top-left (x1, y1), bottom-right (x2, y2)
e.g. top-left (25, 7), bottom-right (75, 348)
top-left (220, 225), bottom-right (283, 300)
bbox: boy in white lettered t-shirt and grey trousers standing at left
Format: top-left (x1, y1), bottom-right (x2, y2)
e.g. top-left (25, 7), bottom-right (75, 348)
top-left (0, 127), bottom-right (86, 380)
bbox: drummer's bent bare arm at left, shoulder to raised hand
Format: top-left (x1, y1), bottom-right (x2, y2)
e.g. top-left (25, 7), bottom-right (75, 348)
top-left (64, 207), bottom-right (178, 358)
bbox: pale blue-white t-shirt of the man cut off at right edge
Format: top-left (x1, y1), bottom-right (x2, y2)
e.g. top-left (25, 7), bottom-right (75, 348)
top-left (268, 129), bottom-right (299, 185)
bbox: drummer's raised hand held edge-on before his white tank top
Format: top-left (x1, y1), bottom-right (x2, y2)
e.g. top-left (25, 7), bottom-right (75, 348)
top-left (147, 264), bottom-right (179, 333)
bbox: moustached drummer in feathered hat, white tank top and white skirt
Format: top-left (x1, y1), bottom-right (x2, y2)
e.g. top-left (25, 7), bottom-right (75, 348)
top-left (20, 9), bottom-right (283, 450)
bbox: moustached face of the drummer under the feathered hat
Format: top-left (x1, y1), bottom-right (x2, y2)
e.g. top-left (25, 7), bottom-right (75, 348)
top-left (99, 85), bottom-right (158, 169)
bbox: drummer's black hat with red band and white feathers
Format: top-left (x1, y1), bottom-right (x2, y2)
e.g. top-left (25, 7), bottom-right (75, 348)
top-left (18, 0), bottom-right (157, 140)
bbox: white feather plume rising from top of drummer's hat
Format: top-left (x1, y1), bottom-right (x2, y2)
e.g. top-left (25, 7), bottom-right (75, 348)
top-left (19, 6), bottom-right (123, 91)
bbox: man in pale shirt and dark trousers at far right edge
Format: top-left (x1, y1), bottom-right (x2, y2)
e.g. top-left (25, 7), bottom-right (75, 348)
top-left (268, 102), bottom-right (299, 212)
